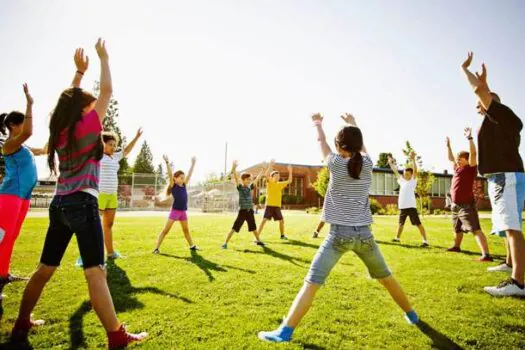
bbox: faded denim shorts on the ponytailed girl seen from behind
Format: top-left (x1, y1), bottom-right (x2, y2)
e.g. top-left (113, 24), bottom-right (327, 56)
top-left (305, 225), bottom-right (392, 284)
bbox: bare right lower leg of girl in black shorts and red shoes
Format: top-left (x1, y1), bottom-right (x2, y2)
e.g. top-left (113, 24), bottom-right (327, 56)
top-left (84, 266), bottom-right (120, 332)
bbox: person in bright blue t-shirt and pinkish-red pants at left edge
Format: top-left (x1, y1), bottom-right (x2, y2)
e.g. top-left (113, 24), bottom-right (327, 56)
top-left (0, 84), bottom-right (37, 300)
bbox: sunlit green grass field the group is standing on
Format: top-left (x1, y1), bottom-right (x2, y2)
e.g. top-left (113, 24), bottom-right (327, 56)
top-left (0, 212), bottom-right (525, 349)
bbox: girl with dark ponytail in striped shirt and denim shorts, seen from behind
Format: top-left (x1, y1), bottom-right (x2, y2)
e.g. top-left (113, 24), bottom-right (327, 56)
top-left (259, 114), bottom-right (419, 343)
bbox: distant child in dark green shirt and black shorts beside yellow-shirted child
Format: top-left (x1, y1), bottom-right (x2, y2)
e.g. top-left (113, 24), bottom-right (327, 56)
top-left (222, 161), bottom-right (264, 249)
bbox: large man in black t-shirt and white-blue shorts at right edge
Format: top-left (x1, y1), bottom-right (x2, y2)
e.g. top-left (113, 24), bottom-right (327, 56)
top-left (462, 52), bottom-right (525, 296)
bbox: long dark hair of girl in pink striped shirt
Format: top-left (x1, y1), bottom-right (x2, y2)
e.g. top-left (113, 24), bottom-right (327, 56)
top-left (47, 88), bottom-right (103, 174)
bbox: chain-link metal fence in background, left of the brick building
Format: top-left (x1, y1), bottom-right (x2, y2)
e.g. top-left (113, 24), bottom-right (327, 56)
top-left (31, 174), bottom-right (239, 213)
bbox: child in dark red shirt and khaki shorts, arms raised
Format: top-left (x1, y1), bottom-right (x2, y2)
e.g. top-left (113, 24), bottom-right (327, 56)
top-left (447, 128), bottom-right (493, 262)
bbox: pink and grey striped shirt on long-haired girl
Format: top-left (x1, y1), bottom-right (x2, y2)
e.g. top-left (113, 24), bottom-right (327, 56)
top-left (56, 110), bottom-right (102, 196)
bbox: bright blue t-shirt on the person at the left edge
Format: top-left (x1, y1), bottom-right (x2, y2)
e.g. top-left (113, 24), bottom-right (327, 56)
top-left (0, 146), bottom-right (38, 199)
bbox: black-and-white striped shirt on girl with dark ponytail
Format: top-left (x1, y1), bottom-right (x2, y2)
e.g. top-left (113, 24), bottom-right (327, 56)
top-left (323, 153), bottom-right (373, 226)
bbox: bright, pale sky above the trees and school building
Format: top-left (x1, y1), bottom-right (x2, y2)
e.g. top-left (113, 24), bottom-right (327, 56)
top-left (0, 0), bottom-right (525, 179)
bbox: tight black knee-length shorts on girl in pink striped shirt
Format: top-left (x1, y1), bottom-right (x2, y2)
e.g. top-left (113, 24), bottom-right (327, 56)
top-left (40, 192), bottom-right (104, 269)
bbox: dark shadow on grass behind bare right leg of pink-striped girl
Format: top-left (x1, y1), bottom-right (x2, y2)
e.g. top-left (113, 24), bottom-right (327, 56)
top-left (69, 260), bottom-right (193, 349)
